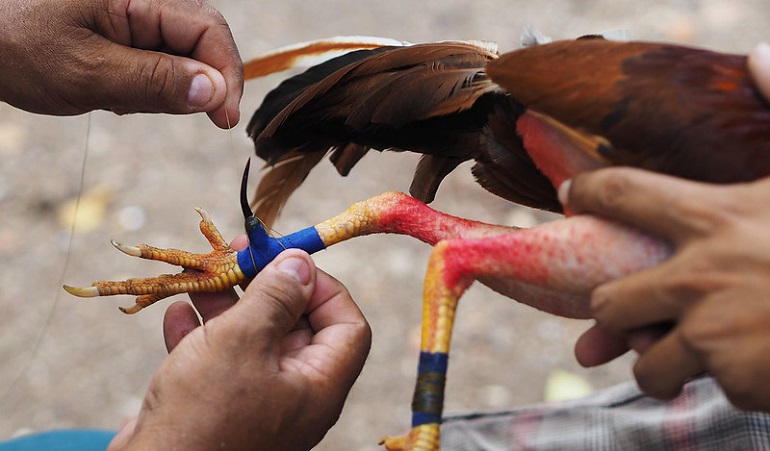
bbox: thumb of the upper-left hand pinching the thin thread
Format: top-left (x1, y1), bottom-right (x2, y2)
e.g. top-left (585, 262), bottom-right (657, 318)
top-left (89, 40), bottom-right (227, 119)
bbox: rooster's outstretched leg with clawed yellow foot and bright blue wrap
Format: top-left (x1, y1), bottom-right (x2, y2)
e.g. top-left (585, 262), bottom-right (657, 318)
top-left (64, 193), bottom-right (504, 313)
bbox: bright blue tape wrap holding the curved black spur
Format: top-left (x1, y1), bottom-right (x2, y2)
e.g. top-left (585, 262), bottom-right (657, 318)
top-left (238, 223), bottom-right (326, 278)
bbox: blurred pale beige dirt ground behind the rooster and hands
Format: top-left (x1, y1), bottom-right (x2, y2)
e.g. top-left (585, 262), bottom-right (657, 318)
top-left (0, 0), bottom-right (770, 450)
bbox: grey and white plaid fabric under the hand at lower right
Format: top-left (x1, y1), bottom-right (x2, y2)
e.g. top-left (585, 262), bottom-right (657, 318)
top-left (441, 377), bottom-right (770, 451)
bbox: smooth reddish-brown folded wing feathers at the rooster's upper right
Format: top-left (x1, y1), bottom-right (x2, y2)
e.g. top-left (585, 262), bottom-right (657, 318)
top-left (487, 39), bottom-right (770, 182)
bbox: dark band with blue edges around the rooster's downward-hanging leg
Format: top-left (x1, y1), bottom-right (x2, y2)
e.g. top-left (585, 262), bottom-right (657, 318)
top-left (412, 352), bottom-right (449, 427)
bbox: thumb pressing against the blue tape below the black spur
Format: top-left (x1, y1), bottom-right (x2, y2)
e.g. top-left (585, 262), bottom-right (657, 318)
top-left (228, 249), bottom-right (317, 339)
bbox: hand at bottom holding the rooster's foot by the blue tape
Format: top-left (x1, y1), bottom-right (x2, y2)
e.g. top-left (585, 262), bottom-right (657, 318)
top-left (109, 250), bottom-right (371, 450)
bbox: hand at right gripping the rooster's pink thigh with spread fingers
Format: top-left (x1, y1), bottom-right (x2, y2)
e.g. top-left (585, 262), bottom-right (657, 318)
top-left (568, 168), bottom-right (770, 410)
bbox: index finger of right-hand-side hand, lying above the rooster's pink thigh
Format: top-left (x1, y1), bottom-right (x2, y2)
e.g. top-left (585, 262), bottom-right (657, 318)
top-left (559, 167), bottom-right (722, 244)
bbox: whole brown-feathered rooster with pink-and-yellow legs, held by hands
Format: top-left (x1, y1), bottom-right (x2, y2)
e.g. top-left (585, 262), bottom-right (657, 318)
top-left (68, 33), bottom-right (770, 450)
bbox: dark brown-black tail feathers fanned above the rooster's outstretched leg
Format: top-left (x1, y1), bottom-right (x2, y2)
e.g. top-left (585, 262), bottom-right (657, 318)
top-left (248, 42), bottom-right (497, 222)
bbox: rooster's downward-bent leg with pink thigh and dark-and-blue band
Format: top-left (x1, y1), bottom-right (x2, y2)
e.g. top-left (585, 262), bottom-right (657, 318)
top-left (382, 217), bottom-right (670, 451)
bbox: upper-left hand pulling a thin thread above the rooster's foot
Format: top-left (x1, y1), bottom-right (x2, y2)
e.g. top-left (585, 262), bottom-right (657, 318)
top-left (0, 0), bottom-right (243, 128)
